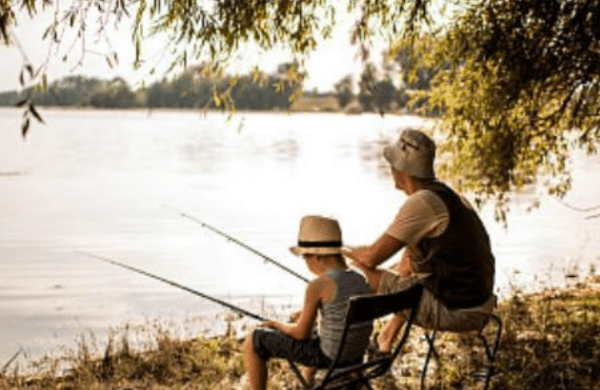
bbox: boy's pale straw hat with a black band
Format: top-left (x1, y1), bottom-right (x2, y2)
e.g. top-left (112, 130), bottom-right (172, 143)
top-left (290, 215), bottom-right (342, 256)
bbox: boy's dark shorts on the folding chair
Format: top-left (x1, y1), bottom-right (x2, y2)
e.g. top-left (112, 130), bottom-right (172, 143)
top-left (252, 328), bottom-right (331, 368)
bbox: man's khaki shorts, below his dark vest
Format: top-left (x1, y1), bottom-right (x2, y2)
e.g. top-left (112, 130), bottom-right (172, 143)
top-left (377, 270), bottom-right (496, 332)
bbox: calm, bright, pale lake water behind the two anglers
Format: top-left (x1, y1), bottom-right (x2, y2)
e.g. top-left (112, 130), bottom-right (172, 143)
top-left (0, 109), bottom-right (600, 365)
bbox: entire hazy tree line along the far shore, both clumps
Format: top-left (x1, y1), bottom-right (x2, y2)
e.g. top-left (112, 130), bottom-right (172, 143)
top-left (0, 52), bottom-right (430, 112)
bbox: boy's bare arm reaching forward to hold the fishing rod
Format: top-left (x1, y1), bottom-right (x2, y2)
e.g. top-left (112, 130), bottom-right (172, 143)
top-left (262, 279), bottom-right (324, 340)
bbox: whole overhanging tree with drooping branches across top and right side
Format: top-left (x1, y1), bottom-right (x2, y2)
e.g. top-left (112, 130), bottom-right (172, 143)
top-left (0, 0), bottom-right (600, 213)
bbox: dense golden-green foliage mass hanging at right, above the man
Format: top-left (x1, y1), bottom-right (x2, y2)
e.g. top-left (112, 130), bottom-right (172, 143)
top-left (395, 0), bottom-right (600, 219)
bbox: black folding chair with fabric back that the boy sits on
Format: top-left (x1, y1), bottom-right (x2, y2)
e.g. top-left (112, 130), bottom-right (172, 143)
top-left (289, 284), bottom-right (423, 390)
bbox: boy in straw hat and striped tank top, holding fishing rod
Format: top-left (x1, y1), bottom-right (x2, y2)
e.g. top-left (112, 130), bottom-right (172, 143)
top-left (243, 216), bottom-right (373, 390)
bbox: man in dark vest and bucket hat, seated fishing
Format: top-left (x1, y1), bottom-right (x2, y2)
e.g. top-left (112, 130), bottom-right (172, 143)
top-left (343, 129), bottom-right (495, 352)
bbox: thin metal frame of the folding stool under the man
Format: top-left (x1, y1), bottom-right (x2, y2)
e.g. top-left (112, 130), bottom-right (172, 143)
top-left (421, 309), bottom-right (502, 390)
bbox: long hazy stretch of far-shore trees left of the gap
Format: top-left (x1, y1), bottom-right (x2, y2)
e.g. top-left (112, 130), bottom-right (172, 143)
top-left (0, 64), bottom-right (298, 110)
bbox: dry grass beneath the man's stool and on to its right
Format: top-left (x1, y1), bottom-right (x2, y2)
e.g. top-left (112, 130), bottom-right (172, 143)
top-left (380, 277), bottom-right (600, 390)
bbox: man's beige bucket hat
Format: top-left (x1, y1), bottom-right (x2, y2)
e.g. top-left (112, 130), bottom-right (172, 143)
top-left (383, 129), bottom-right (435, 179)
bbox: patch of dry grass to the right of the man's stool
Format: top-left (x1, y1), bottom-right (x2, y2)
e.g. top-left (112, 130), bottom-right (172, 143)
top-left (497, 280), bottom-right (600, 390)
